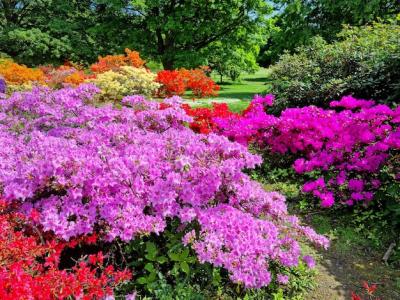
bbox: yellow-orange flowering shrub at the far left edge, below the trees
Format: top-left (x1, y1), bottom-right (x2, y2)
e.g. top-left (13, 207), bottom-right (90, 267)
top-left (0, 60), bottom-right (44, 84)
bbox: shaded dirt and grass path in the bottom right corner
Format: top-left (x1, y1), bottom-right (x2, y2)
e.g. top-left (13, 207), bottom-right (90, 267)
top-left (306, 214), bottom-right (400, 299)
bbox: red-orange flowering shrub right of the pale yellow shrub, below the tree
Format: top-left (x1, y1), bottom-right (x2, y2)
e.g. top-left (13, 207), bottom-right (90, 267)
top-left (156, 69), bottom-right (220, 97)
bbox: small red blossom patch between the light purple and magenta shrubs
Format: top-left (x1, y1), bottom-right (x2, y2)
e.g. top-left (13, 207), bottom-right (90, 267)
top-left (182, 102), bottom-right (239, 134)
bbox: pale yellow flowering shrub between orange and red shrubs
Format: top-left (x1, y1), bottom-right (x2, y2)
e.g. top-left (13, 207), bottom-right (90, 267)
top-left (91, 66), bottom-right (160, 101)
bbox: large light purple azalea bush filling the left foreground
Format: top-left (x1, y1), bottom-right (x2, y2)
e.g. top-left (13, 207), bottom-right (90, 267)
top-left (0, 85), bottom-right (328, 287)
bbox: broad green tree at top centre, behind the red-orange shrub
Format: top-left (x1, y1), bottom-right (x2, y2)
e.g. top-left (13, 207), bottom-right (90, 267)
top-left (126, 0), bottom-right (271, 69)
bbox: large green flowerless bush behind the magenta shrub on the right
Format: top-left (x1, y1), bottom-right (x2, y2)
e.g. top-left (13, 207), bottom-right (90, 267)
top-left (271, 22), bottom-right (400, 111)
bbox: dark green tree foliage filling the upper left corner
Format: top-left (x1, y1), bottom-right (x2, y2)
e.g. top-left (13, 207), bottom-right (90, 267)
top-left (0, 0), bottom-right (132, 66)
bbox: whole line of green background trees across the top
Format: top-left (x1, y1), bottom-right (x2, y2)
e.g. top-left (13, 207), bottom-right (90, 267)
top-left (0, 0), bottom-right (400, 74)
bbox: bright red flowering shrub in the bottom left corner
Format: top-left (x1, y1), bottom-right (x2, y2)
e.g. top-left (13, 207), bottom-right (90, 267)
top-left (0, 201), bottom-right (131, 300)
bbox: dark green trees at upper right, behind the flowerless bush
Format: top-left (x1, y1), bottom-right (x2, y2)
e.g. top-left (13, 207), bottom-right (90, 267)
top-left (259, 0), bottom-right (400, 66)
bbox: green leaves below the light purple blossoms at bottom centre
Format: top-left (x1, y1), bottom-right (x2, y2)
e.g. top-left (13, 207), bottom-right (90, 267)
top-left (118, 219), bottom-right (315, 299)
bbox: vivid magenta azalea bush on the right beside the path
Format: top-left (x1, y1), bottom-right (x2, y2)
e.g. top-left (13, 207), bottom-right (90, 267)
top-left (214, 95), bottom-right (400, 207)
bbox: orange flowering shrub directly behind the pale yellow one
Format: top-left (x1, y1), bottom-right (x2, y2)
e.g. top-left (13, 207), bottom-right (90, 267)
top-left (90, 49), bottom-right (145, 73)
